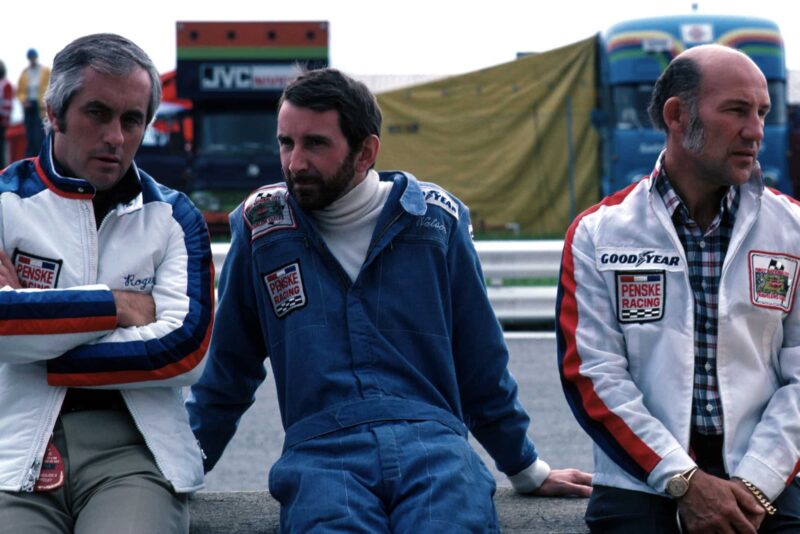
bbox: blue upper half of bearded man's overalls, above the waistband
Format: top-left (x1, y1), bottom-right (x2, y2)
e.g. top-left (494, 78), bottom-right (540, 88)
top-left (187, 172), bottom-right (537, 475)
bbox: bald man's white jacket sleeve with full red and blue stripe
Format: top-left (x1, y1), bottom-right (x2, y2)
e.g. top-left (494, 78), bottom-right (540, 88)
top-left (556, 218), bottom-right (694, 491)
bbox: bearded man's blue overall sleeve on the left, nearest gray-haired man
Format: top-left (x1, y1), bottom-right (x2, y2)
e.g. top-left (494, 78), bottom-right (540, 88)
top-left (186, 207), bottom-right (267, 472)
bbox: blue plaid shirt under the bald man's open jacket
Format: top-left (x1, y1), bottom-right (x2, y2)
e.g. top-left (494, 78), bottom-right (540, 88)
top-left (655, 172), bottom-right (739, 435)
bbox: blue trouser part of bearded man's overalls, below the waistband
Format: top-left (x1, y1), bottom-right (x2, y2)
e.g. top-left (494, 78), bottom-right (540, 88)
top-left (270, 422), bottom-right (497, 534)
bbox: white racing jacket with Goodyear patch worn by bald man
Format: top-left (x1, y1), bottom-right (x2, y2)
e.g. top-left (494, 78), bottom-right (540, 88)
top-left (557, 157), bottom-right (800, 500)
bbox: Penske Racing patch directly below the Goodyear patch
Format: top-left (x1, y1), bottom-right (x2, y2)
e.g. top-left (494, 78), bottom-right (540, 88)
top-left (615, 271), bottom-right (667, 323)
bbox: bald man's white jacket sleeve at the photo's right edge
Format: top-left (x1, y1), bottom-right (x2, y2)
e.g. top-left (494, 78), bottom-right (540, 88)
top-left (733, 304), bottom-right (800, 501)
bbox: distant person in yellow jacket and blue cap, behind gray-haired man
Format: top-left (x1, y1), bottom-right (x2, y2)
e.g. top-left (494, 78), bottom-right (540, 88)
top-left (17, 48), bottom-right (50, 158)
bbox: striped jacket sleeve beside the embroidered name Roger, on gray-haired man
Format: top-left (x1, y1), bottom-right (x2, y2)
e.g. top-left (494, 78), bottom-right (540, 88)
top-left (47, 195), bottom-right (214, 389)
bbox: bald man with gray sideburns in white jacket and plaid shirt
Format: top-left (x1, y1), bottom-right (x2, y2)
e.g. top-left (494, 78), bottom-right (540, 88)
top-left (557, 45), bottom-right (800, 533)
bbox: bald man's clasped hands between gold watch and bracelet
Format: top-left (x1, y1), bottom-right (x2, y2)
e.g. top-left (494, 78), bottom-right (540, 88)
top-left (678, 469), bottom-right (766, 534)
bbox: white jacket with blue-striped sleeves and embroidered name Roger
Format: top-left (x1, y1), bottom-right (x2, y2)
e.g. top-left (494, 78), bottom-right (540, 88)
top-left (0, 138), bottom-right (214, 492)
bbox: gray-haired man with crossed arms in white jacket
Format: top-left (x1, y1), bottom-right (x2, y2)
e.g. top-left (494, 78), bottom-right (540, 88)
top-left (0, 34), bottom-right (214, 534)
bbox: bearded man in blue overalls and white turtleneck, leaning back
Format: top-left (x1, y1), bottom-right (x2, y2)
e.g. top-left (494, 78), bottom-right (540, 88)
top-left (187, 69), bottom-right (591, 532)
